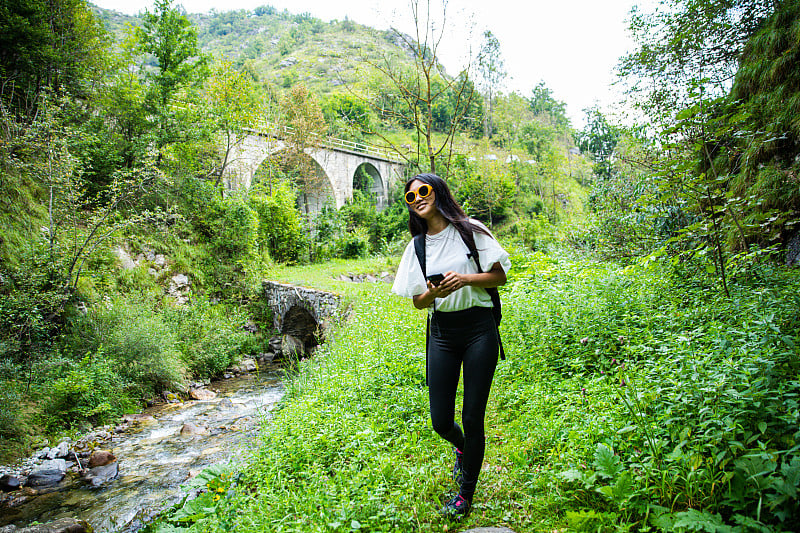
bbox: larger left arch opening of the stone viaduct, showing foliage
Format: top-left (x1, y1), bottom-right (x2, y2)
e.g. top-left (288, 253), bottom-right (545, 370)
top-left (252, 148), bottom-right (336, 213)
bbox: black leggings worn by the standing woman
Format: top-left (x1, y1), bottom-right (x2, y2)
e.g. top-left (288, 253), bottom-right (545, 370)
top-left (428, 307), bottom-right (498, 497)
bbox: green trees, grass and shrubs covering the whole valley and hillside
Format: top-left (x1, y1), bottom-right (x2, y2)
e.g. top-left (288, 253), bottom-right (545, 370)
top-left (0, 0), bottom-right (800, 533)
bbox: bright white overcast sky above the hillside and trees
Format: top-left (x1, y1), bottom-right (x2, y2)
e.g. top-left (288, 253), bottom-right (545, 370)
top-left (90, 0), bottom-right (652, 128)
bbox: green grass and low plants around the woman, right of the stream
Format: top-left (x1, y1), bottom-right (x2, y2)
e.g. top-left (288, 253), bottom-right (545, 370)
top-left (147, 249), bottom-right (800, 533)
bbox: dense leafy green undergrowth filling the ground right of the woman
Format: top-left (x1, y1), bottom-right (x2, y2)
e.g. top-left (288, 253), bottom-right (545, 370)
top-left (498, 250), bottom-right (800, 531)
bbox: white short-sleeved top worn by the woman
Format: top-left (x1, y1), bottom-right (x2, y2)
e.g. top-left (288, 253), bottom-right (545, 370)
top-left (392, 219), bottom-right (511, 312)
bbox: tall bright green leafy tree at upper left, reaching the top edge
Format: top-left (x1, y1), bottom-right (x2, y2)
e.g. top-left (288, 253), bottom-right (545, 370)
top-left (136, 0), bottom-right (208, 154)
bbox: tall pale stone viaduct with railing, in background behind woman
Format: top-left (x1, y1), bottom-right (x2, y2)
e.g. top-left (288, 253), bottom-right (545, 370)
top-left (222, 127), bottom-right (405, 211)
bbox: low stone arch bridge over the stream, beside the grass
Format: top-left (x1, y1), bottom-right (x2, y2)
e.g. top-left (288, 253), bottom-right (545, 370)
top-left (262, 281), bottom-right (344, 350)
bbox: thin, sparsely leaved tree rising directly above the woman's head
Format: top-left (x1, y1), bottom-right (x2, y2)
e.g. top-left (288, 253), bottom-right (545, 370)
top-left (370, 0), bottom-right (474, 173)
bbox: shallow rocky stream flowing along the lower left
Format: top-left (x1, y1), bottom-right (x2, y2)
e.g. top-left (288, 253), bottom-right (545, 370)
top-left (0, 367), bottom-right (283, 533)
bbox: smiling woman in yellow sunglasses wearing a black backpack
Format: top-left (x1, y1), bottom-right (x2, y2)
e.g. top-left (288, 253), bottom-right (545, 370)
top-left (392, 174), bottom-right (511, 517)
